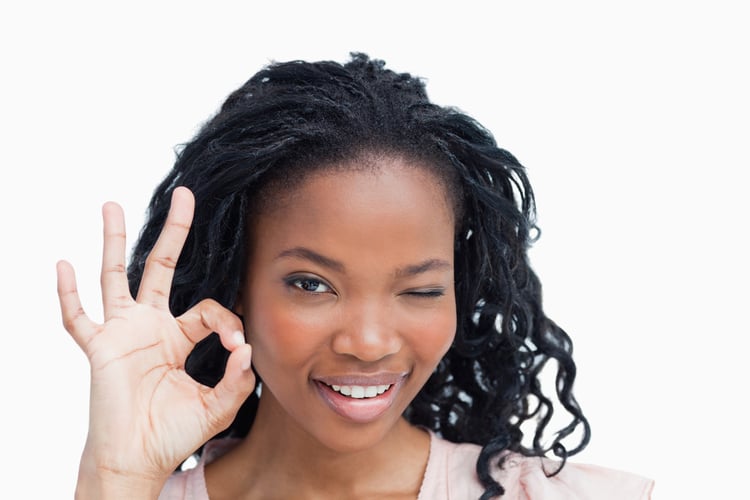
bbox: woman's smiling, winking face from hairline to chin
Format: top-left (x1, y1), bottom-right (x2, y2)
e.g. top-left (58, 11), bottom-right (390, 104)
top-left (237, 158), bottom-right (456, 451)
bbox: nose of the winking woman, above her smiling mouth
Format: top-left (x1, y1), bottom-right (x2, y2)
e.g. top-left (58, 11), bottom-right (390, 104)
top-left (332, 302), bottom-right (402, 362)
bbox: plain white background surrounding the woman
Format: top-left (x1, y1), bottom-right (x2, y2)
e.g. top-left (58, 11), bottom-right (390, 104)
top-left (0, 0), bottom-right (750, 499)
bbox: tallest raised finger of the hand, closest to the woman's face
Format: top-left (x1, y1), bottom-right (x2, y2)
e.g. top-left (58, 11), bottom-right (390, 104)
top-left (136, 187), bottom-right (195, 309)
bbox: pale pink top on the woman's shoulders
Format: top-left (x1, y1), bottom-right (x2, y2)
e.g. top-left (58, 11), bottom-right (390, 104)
top-left (159, 433), bottom-right (654, 500)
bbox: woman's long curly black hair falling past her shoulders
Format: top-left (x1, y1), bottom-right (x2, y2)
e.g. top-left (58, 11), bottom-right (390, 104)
top-left (128, 53), bottom-right (590, 498)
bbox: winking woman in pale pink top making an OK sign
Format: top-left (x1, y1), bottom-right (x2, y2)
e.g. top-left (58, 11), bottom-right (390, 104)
top-left (58, 54), bottom-right (651, 499)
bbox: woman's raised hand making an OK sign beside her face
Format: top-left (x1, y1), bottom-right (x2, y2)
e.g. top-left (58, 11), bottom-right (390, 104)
top-left (57, 187), bottom-right (255, 498)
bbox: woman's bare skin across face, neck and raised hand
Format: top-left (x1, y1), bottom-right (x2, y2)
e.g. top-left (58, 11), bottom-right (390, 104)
top-left (59, 157), bottom-right (456, 500)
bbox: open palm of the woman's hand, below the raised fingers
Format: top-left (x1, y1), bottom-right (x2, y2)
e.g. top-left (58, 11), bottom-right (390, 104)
top-left (86, 304), bottom-right (210, 471)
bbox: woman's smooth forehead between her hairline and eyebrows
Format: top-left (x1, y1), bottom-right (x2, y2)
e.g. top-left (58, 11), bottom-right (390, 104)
top-left (250, 159), bottom-right (454, 261)
